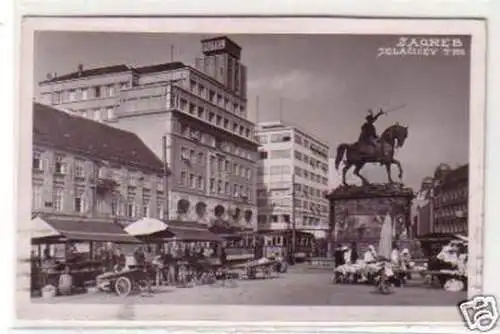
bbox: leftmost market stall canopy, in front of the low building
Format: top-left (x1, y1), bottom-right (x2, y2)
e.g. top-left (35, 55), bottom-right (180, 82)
top-left (31, 216), bottom-right (140, 243)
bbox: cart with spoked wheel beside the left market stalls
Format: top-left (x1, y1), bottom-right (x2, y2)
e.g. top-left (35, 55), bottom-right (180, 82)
top-left (96, 268), bottom-right (148, 296)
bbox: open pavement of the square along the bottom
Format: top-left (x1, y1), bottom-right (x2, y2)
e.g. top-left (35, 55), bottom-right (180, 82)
top-left (33, 271), bottom-right (466, 306)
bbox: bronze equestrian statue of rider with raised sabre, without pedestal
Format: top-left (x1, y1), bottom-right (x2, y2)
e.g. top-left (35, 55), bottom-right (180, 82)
top-left (335, 108), bottom-right (408, 186)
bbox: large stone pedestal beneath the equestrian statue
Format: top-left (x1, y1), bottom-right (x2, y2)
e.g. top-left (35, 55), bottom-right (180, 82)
top-left (327, 184), bottom-right (414, 255)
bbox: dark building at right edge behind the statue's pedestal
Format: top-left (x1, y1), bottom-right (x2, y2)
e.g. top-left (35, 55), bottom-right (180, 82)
top-left (417, 164), bottom-right (469, 235)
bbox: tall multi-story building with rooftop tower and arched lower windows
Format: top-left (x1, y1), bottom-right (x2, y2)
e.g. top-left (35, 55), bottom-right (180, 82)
top-left (40, 37), bottom-right (258, 228)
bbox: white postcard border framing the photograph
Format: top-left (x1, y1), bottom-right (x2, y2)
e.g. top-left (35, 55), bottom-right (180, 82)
top-left (16, 18), bottom-right (486, 328)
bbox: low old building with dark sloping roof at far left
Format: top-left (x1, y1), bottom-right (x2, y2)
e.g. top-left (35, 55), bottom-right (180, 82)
top-left (32, 103), bottom-right (165, 224)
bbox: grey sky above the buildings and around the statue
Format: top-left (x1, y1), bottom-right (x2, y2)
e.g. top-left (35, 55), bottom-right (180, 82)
top-left (34, 32), bottom-right (470, 190)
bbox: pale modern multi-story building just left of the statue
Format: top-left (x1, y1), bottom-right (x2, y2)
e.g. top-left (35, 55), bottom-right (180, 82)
top-left (257, 122), bottom-right (329, 238)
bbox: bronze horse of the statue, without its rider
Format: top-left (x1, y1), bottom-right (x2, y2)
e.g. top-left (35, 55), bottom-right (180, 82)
top-left (335, 124), bottom-right (408, 185)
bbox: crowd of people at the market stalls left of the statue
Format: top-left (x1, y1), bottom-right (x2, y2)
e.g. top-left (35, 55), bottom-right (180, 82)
top-left (31, 242), bottom-right (231, 294)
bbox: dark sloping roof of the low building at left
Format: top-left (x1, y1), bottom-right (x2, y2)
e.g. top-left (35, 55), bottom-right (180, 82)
top-left (33, 102), bottom-right (163, 173)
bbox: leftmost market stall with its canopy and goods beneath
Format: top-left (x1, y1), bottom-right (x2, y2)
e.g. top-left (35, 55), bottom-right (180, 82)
top-left (31, 216), bottom-right (140, 294)
